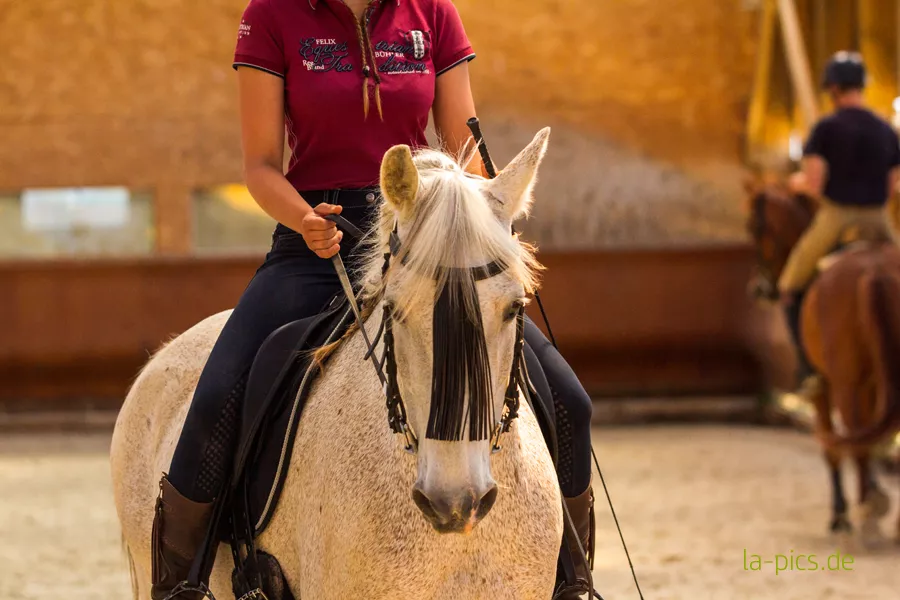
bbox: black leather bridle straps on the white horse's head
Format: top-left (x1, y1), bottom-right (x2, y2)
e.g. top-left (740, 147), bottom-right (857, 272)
top-left (328, 215), bottom-right (527, 454)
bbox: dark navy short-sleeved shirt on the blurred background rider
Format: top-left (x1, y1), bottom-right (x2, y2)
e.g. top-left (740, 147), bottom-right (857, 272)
top-left (803, 108), bottom-right (900, 207)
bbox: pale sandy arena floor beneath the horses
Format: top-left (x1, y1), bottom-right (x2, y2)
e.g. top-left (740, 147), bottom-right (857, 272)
top-left (0, 425), bottom-right (900, 600)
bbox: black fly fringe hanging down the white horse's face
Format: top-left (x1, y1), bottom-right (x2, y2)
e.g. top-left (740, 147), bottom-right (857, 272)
top-left (426, 271), bottom-right (493, 441)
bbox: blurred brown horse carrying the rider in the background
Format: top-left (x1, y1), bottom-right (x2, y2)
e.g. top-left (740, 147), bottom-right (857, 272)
top-left (748, 180), bottom-right (900, 543)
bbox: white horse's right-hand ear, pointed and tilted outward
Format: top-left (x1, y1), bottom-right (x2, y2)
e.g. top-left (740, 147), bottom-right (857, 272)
top-left (487, 127), bottom-right (550, 221)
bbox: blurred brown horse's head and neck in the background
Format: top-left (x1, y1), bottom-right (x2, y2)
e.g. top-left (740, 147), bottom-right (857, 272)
top-left (745, 177), bottom-right (816, 299)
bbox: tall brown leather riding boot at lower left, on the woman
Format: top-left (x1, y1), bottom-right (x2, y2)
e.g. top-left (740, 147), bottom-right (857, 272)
top-left (150, 475), bottom-right (213, 600)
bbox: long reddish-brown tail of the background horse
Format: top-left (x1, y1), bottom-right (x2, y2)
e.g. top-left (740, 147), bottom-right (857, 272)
top-left (833, 272), bottom-right (900, 447)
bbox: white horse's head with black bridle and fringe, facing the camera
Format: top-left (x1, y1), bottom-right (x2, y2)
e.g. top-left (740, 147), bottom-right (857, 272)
top-left (368, 129), bottom-right (550, 533)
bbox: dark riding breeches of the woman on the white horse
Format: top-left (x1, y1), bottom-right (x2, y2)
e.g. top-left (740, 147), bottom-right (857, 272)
top-left (168, 190), bottom-right (591, 502)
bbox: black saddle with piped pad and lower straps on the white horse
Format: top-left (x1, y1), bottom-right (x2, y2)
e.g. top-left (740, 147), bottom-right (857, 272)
top-left (191, 292), bottom-right (558, 600)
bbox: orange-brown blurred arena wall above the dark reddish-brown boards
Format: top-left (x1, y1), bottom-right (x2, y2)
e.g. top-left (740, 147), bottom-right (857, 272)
top-left (0, 0), bottom-right (758, 247)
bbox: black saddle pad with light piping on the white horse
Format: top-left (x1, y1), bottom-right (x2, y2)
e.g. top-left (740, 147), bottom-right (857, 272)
top-left (229, 294), bottom-right (557, 542)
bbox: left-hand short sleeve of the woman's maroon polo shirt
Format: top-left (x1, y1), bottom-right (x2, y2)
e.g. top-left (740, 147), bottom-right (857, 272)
top-left (232, 0), bottom-right (285, 77)
